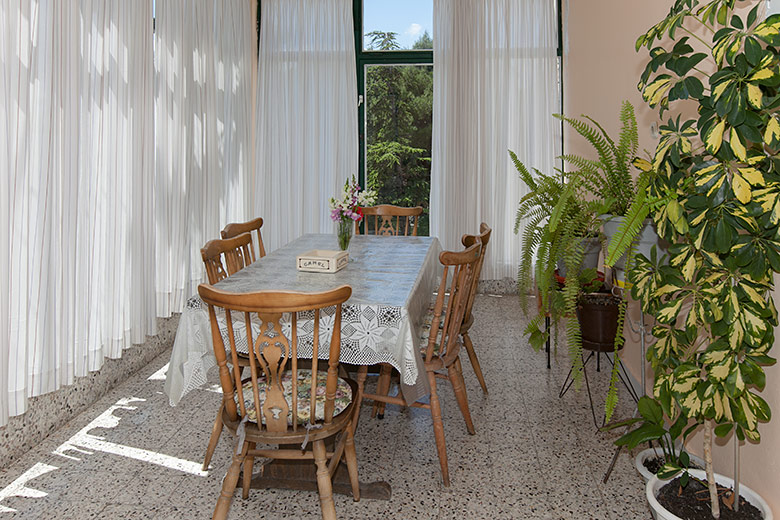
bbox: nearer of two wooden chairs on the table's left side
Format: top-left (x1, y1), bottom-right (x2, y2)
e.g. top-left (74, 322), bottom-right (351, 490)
top-left (200, 233), bottom-right (252, 471)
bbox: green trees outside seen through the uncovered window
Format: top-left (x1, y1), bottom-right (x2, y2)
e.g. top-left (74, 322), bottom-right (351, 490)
top-left (365, 31), bottom-right (433, 235)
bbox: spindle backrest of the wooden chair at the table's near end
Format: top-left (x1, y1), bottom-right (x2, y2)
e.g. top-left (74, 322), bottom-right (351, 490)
top-left (198, 284), bottom-right (352, 432)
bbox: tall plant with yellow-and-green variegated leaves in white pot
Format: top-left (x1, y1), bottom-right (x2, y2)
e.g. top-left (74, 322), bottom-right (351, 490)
top-left (608, 0), bottom-right (780, 519)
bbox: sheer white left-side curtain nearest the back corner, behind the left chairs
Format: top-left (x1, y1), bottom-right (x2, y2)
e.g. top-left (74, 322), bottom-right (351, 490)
top-left (155, 0), bottom-right (257, 316)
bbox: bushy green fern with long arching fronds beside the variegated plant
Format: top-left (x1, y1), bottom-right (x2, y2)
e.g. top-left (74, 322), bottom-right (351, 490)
top-left (509, 101), bottom-right (644, 420)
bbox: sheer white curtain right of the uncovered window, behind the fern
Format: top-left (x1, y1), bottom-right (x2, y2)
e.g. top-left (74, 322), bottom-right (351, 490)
top-left (431, 0), bottom-right (560, 279)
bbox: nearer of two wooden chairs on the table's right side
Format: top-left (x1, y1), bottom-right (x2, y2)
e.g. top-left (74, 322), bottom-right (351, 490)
top-left (358, 243), bottom-right (482, 486)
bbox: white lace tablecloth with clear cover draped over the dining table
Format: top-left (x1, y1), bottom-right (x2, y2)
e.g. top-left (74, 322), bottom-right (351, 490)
top-left (165, 234), bottom-right (441, 406)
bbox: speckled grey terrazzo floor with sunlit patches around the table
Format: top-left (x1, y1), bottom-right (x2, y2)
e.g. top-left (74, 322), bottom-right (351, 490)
top-left (0, 295), bottom-right (650, 520)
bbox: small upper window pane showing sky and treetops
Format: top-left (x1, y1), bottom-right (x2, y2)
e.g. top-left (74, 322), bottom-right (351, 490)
top-left (363, 0), bottom-right (433, 51)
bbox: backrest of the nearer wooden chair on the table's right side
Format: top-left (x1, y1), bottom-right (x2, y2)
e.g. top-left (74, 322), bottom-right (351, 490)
top-left (425, 243), bottom-right (482, 364)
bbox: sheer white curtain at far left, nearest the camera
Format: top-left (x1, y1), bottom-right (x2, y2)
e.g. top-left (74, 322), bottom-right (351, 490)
top-left (0, 0), bottom-right (155, 425)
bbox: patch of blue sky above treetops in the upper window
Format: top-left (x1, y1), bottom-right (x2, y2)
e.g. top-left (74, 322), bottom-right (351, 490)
top-left (363, 0), bottom-right (433, 49)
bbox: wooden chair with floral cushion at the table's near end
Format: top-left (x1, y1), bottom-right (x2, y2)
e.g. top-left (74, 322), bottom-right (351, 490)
top-left (198, 284), bottom-right (360, 519)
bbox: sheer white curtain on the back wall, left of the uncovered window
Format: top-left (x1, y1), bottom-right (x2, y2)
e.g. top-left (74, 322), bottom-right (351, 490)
top-left (252, 0), bottom-right (358, 250)
